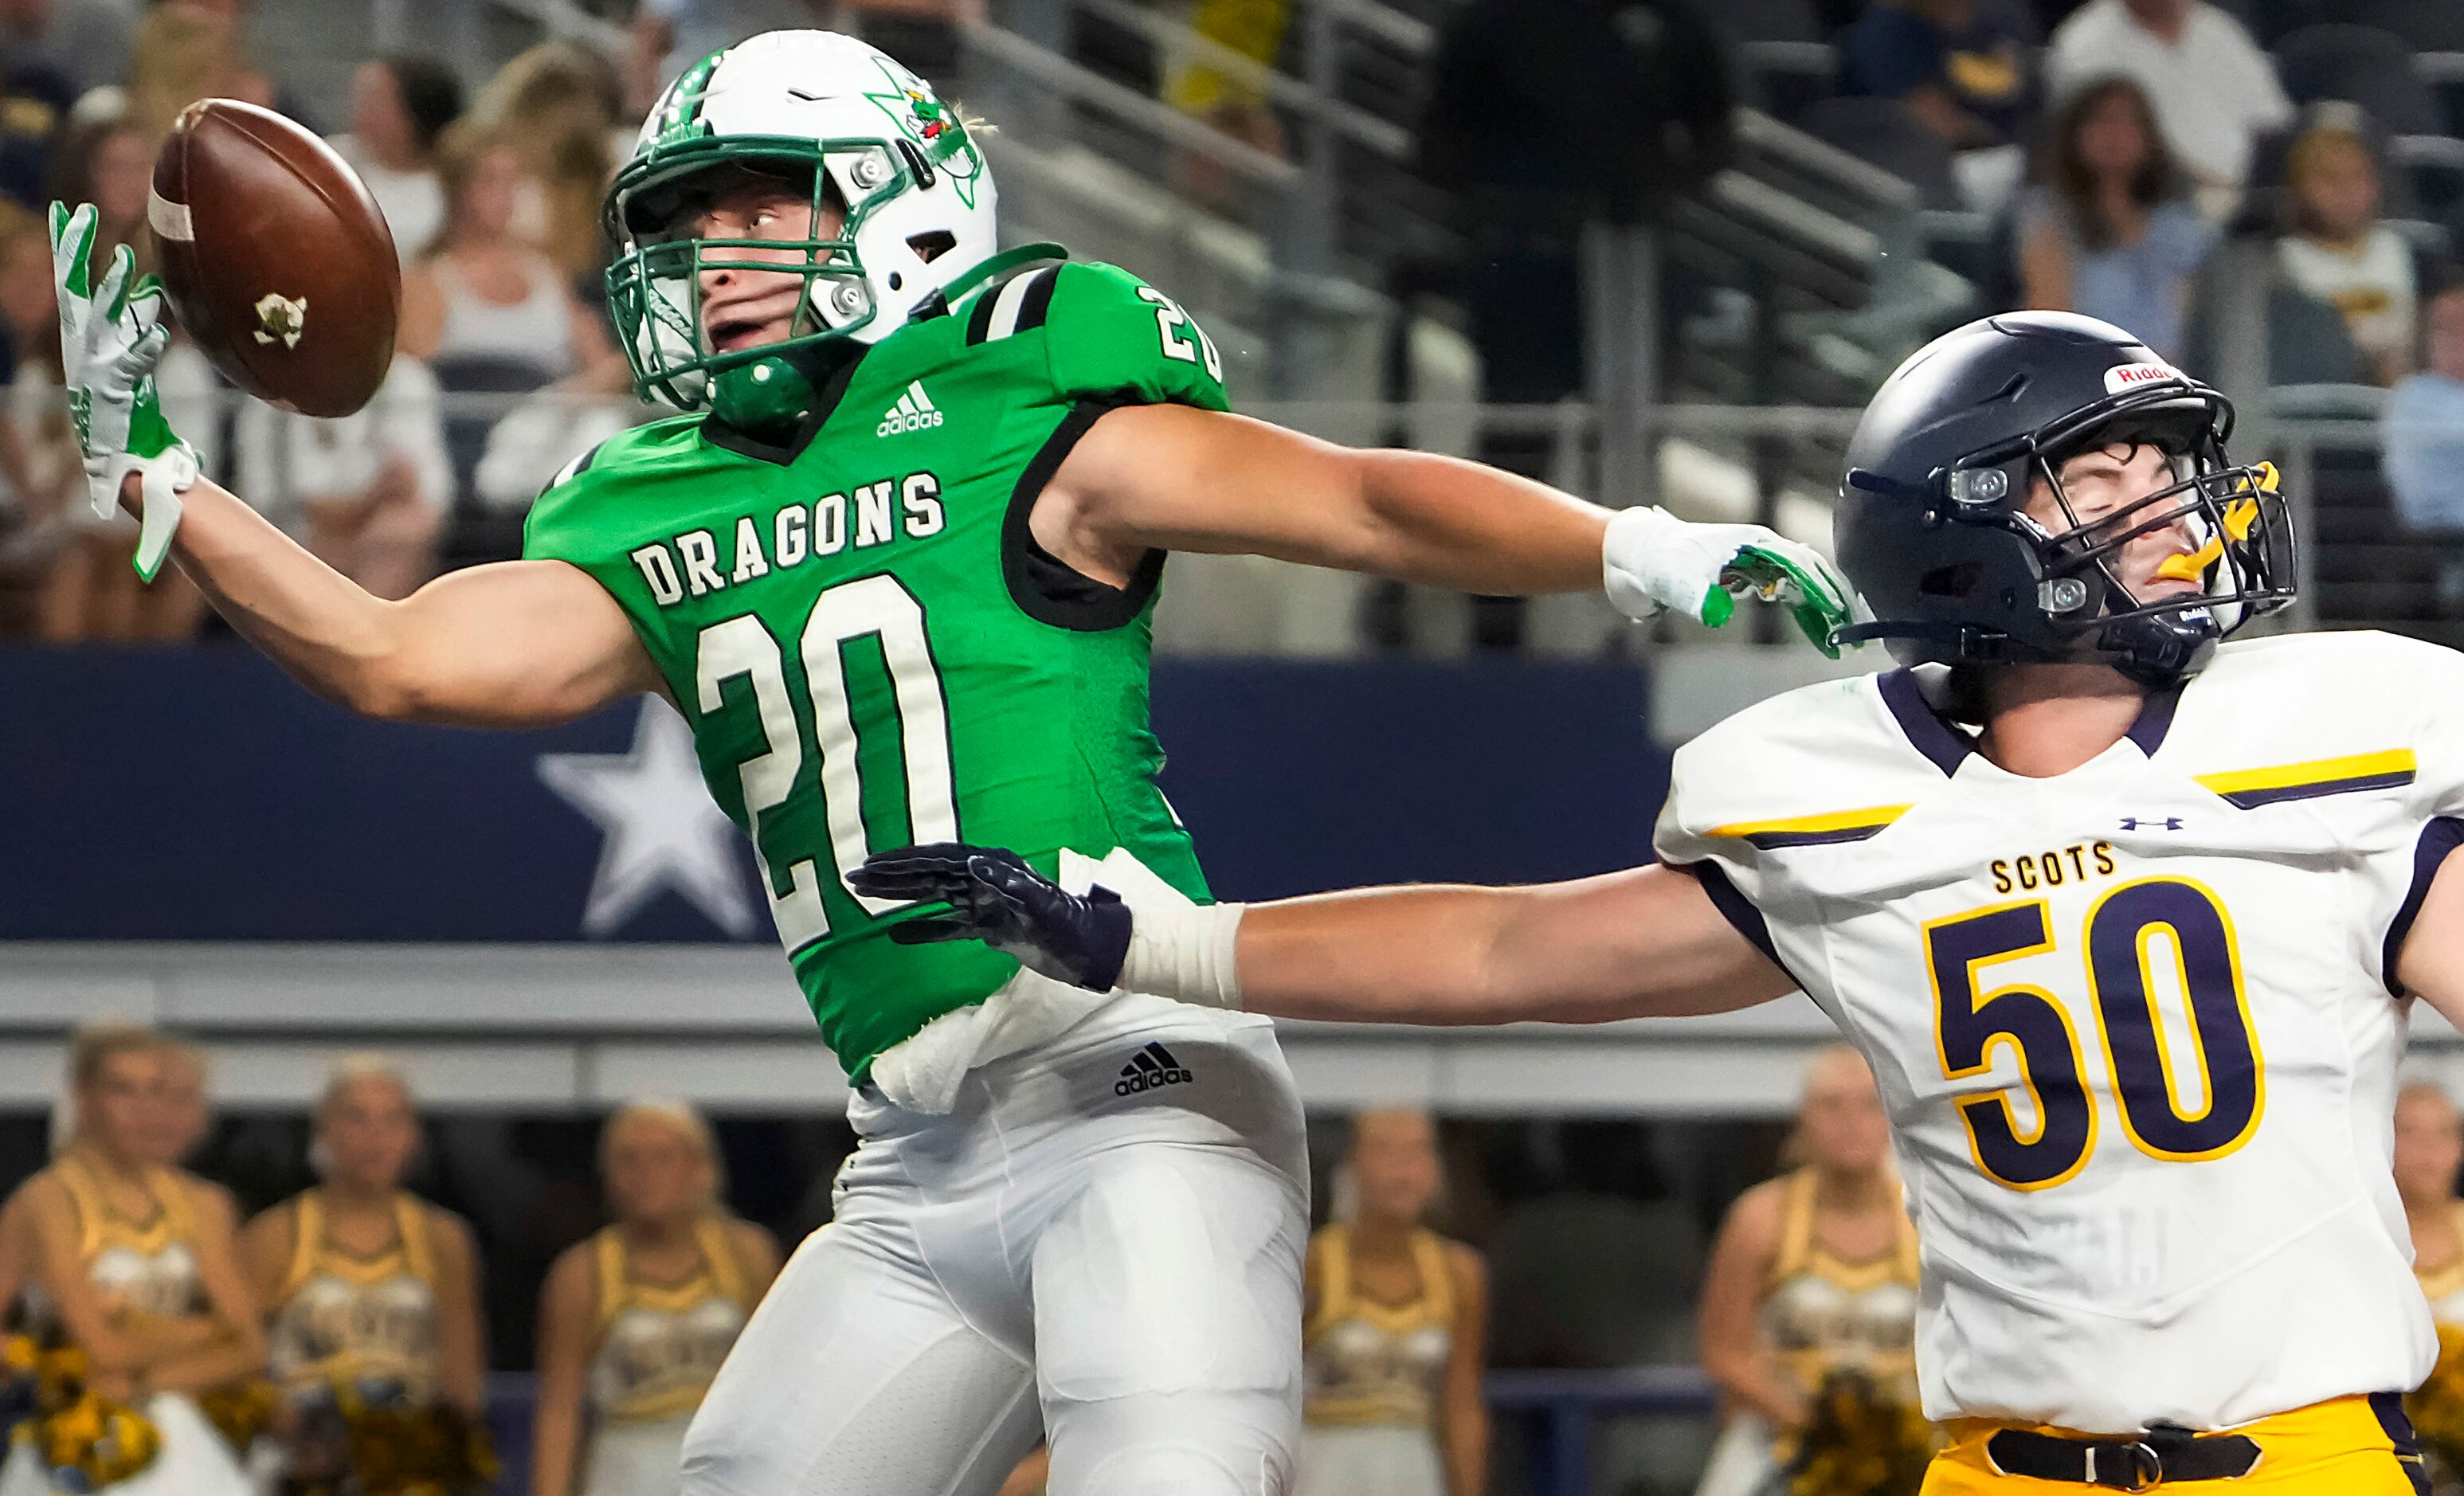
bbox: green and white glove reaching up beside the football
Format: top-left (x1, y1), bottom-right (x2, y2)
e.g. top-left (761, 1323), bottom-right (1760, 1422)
top-left (52, 202), bottom-right (197, 582)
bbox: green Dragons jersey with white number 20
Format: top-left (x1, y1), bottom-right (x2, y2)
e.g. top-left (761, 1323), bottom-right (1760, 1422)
top-left (537, 261), bottom-right (1224, 1079)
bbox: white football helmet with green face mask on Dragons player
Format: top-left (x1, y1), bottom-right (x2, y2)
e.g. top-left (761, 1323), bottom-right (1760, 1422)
top-left (606, 32), bottom-right (998, 417)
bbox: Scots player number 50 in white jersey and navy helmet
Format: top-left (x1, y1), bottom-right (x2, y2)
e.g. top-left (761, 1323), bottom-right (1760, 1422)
top-left (865, 313), bottom-right (2464, 1496)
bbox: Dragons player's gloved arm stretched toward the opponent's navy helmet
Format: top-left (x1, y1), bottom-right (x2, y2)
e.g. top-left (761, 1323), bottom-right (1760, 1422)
top-left (1030, 404), bottom-right (1851, 651)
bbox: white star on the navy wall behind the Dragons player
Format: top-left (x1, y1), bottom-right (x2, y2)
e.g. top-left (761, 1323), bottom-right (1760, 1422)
top-left (539, 695), bottom-right (757, 937)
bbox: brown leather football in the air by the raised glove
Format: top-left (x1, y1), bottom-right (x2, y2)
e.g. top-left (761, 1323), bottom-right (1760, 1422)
top-left (145, 99), bottom-right (402, 417)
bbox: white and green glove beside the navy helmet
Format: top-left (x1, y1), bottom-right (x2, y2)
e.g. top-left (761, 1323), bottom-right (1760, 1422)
top-left (1601, 507), bottom-right (1855, 660)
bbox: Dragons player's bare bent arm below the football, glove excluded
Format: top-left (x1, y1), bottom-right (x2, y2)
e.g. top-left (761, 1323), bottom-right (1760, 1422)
top-left (159, 476), bottom-right (660, 727)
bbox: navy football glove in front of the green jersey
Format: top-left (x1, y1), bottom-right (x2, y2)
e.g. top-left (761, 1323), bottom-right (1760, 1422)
top-left (848, 840), bottom-right (1129, 993)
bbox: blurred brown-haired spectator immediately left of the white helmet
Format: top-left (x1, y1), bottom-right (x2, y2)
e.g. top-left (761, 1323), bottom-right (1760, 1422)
top-left (471, 40), bottom-right (625, 283)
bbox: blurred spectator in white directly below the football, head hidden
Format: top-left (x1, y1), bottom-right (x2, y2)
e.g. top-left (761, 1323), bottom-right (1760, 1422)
top-left (232, 352), bottom-right (453, 599)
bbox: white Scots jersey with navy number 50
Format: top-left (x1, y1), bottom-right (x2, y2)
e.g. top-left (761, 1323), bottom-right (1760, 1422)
top-left (1659, 633), bottom-right (2464, 1432)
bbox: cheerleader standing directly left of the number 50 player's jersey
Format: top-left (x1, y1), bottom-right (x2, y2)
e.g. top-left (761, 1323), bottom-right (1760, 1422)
top-left (1695, 1045), bottom-right (1929, 1496)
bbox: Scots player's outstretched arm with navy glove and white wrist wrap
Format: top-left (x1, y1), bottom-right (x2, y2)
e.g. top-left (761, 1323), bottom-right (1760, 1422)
top-left (850, 845), bottom-right (1796, 1023)
